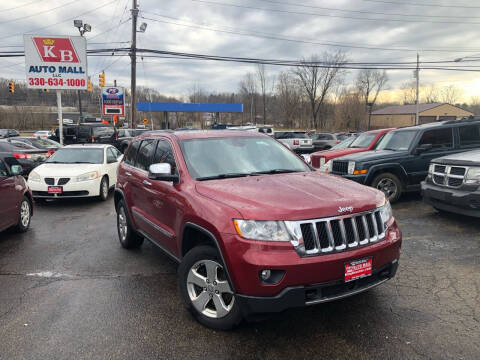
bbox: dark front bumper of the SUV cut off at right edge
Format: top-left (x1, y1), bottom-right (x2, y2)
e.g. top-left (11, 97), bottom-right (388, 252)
top-left (421, 181), bottom-right (480, 217)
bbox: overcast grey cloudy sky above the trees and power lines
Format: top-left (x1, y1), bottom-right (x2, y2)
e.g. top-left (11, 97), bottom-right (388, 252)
top-left (0, 0), bottom-right (480, 100)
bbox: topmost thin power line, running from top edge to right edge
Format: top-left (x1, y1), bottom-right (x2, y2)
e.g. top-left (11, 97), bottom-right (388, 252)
top-left (191, 0), bottom-right (480, 25)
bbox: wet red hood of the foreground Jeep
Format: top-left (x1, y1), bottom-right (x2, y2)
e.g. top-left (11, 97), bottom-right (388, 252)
top-left (196, 171), bottom-right (385, 220)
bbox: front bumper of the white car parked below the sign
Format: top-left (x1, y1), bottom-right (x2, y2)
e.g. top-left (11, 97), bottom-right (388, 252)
top-left (28, 176), bottom-right (101, 199)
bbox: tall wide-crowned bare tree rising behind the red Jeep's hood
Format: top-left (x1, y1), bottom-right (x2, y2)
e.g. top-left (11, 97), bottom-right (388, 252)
top-left (294, 51), bottom-right (346, 129)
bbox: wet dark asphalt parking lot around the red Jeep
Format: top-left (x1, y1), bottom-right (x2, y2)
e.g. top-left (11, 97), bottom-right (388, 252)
top-left (0, 195), bottom-right (480, 359)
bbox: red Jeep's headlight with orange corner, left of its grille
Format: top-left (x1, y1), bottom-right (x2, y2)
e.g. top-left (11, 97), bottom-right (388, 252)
top-left (233, 220), bottom-right (291, 241)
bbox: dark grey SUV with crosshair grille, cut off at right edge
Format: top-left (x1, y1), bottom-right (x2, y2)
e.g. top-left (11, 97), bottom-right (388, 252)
top-left (421, 149), bottom-right (480, 217)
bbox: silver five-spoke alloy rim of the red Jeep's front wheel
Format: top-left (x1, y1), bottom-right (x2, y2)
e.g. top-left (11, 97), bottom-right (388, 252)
top-left (187, 260), bottom-right (235, 319)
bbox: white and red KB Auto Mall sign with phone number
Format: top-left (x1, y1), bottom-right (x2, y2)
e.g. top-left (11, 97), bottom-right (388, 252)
top-left (23, 35), bottom-right (88, 90)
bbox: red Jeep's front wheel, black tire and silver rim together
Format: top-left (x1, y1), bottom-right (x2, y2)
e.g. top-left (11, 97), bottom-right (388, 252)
top-left (178, 245), bottom-right (242, 330)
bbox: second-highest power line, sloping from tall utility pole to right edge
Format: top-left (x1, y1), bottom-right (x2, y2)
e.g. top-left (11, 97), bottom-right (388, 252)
top-left (142, 12), bottom-right (479, 53)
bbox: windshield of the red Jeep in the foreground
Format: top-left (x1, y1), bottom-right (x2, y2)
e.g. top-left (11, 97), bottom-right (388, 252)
top-left (182, 136), bottom-right (310, 180)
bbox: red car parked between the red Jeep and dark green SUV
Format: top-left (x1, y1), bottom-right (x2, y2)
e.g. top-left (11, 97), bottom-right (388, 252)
top-left (310, 129), bottom-right (393, 172)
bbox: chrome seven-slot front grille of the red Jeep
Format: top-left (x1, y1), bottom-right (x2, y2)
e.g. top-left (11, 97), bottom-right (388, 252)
top-left (295, 209), bottom-right (386, 256)
